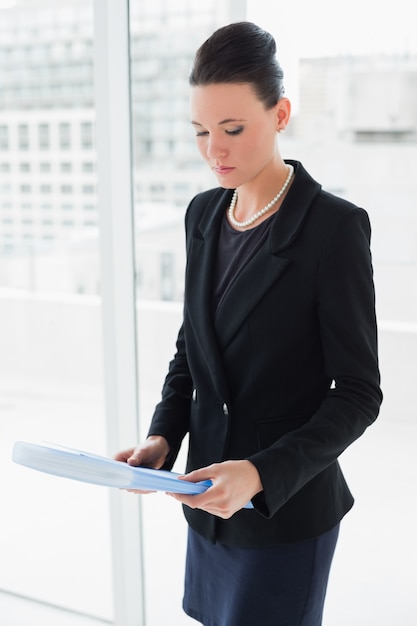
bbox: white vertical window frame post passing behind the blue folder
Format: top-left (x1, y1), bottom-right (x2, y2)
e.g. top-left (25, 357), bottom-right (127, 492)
top-left (94, 0), bottom-right (145, 626)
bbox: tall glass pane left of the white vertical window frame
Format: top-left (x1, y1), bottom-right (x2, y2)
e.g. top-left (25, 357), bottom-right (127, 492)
top-left (0, 0), bottom-right (113, 624)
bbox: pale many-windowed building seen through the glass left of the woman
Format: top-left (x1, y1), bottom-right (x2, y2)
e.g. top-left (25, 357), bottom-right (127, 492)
top-left (0, 0), bottom-right (239, 299)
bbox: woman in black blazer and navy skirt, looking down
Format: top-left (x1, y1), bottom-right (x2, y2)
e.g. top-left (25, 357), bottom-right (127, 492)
top-left (115, 22), bottom-right (382, 626)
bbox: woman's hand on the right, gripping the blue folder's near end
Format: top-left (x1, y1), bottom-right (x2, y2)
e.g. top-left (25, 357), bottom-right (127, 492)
top-left (169, 460), bottom-right (263, 519)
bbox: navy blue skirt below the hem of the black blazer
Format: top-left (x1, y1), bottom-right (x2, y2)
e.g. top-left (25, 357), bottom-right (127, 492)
top-left (183, 525), bottom-right (339, 626)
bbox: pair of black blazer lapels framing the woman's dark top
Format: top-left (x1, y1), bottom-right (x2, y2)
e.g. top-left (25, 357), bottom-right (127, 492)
top-left (185, 161), bottom-right (321, 390)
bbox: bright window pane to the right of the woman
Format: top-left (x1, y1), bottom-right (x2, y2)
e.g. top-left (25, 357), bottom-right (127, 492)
top-left (248, 0), bottom-right (417, 626)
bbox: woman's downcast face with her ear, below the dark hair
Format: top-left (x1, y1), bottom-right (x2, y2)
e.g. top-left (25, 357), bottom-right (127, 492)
top-left (191, 83), bottom-right (289, 189)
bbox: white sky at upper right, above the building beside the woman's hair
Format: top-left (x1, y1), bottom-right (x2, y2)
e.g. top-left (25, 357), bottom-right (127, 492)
top-left (247, 0), bottom-right (417, 111)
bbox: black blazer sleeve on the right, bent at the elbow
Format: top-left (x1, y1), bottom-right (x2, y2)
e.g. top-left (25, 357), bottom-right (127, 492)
top-left (249, 207), bottom-right (382, 517)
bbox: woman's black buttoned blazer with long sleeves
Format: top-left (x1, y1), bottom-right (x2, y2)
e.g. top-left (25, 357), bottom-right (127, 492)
top-left (149, 161), bottom-right (382, 546)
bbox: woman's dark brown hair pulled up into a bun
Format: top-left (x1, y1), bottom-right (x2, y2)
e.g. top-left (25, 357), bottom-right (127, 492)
top-left (189, 22), bottom-right (284, 109)
